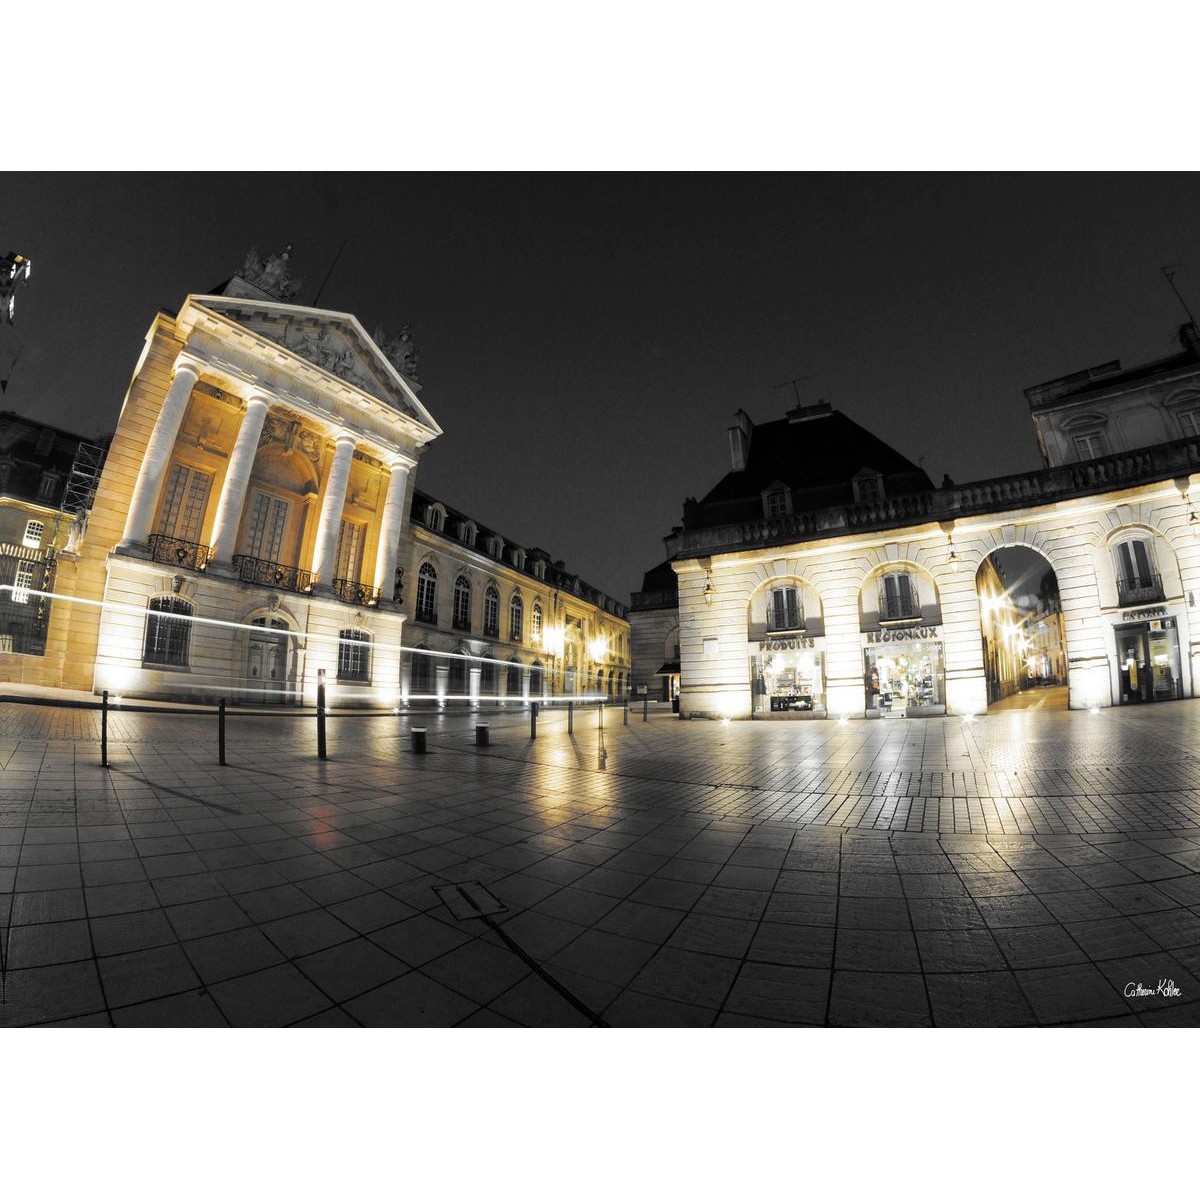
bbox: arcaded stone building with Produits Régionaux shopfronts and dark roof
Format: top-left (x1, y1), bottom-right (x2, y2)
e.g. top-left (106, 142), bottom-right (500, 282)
top-left (662, 326), bottom-right (1200, 718)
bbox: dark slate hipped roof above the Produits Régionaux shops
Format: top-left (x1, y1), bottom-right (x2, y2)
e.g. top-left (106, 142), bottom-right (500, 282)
top-left (684, 410), bottom-right (934, 529)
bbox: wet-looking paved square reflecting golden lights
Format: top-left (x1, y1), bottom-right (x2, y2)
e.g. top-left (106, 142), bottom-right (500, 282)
top-left (0, 702), bottom-right (1200, 1026)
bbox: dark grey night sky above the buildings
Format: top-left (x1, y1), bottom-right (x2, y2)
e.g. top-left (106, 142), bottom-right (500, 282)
top-left (0, 173), bottom-right (1200, 600)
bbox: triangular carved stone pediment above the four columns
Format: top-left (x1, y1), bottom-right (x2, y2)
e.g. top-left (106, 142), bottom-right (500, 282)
top-left (192, 296), bottom-right (440, 432)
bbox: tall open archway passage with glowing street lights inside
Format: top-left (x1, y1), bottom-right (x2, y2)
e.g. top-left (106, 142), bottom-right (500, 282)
top-left (976, 546), bottom-right (1067, 710)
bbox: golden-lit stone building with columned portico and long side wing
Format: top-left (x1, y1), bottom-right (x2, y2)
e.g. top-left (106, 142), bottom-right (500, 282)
top-left (30, 253), bottom-right (628, 704)
